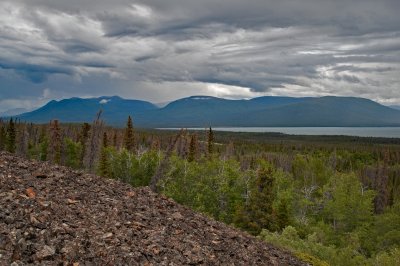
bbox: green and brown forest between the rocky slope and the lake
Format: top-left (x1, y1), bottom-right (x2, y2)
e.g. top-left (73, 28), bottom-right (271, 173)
top-left (0, 113), bottom-right (400, 265)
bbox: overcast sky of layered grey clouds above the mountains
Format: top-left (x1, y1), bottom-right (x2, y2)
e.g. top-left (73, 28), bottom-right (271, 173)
top-left (0, 0), bottom-right (400, 111)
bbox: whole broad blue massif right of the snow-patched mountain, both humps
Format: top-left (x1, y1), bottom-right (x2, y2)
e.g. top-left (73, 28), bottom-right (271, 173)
top-left (136, 97), bottom-right (400, 127)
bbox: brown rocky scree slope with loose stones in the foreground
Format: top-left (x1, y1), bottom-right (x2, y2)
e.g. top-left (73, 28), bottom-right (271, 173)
top-left (0, 153), bottom-right (305, 266)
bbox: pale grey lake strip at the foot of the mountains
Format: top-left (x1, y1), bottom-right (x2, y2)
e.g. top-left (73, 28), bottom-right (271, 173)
top-left (163, 127), bottom-right (400, 138)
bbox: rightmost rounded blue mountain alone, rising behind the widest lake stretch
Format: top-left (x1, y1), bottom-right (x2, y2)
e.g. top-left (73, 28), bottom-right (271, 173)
top-left (243, 96), bottom-right (400, 127)
